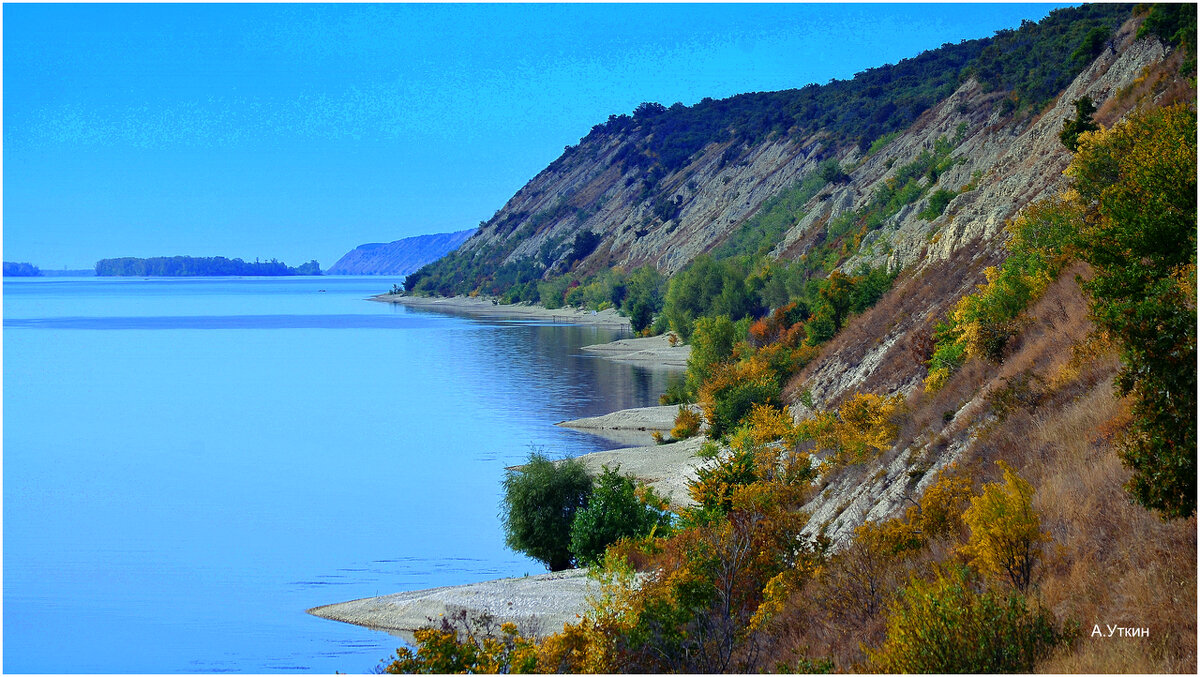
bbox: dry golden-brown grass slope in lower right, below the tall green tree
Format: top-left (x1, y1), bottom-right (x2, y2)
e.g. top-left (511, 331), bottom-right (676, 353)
top-left (950, 266), bottom-right (1196, 672)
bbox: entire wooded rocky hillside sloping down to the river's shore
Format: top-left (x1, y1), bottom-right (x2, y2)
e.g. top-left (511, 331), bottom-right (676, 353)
top-left (314, 5), bottom-right (1196, 673)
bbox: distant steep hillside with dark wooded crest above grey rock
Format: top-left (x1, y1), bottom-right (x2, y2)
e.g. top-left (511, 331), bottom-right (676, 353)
top-left (408, 5), bottom-right (1129, 296)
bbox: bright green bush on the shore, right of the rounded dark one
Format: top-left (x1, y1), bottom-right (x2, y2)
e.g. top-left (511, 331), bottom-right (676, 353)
top-left (571, 466), bottom-right (671, 565)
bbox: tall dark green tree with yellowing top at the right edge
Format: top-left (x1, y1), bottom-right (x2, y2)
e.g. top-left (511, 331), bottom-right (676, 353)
top-left (1067, 106), bottom-right (1196, 517)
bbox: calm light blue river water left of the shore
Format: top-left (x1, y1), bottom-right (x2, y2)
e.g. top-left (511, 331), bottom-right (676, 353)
top-left (2, 277), bottom-right (674, 672)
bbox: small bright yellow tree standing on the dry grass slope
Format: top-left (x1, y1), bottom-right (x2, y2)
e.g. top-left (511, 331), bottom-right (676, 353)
top-left (962, 461), bottom-right (1050, 591)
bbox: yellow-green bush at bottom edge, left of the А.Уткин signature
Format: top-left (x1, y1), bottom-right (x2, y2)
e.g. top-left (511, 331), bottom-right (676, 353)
top-left (868, 567), bottom-right (1076, 673)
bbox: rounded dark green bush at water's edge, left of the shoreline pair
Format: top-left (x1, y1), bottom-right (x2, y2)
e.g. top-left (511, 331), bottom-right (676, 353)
top-left (500, 451), bottom-right (592, 571)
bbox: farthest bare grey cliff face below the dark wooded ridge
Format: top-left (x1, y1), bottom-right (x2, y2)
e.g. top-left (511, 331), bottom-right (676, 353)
top-left (463, 127), bottom-right (833, 275)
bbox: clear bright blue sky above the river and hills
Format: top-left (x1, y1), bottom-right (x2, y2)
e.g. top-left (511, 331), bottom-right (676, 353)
top-left (4, 4), bottom-right (1075, 269)
